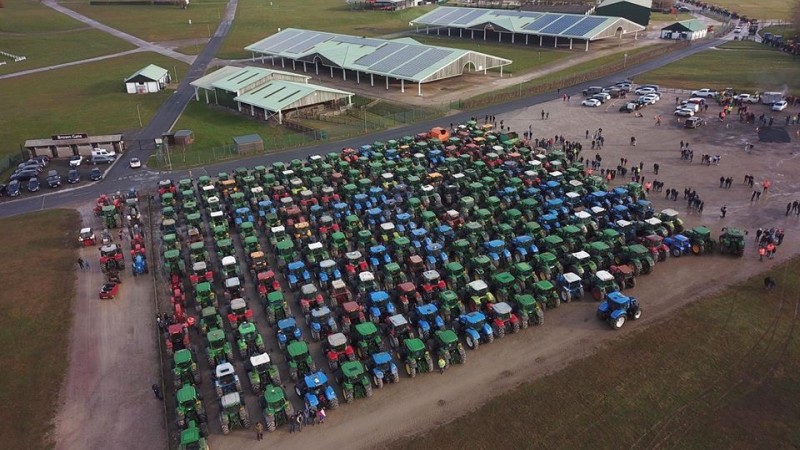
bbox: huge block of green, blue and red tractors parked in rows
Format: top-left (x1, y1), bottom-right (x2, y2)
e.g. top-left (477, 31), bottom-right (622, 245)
top-left (153, 122), bottom-right (744, 446)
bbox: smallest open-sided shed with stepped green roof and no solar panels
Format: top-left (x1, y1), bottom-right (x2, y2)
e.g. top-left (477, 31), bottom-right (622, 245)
top-left (191, 66), bottom-right (354, 123)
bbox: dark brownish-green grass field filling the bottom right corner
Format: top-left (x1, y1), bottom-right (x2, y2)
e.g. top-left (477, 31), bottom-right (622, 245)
top-left (394, 260), bottom-right (800, 449)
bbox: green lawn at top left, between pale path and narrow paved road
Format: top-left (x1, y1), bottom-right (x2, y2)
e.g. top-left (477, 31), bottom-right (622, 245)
top-left (60, 0), bottom-right (227, 42)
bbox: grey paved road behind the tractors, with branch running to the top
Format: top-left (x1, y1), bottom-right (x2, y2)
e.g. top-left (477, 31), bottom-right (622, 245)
top-left (0, 35), bottom-right (726, 217)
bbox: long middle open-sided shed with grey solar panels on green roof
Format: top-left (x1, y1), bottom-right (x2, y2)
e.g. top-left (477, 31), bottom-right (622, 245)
top-left (245, 28), bottom-right (511, 96)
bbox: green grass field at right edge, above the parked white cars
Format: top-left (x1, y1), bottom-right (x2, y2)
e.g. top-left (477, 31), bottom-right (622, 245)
top-left (636, 41), bottom-right (800, 92)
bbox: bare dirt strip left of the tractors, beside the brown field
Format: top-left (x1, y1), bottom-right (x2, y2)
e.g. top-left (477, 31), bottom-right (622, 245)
top-left (56, 205), bottom-right (167, 450)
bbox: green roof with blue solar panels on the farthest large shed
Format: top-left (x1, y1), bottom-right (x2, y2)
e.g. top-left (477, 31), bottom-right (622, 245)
top-left (411, 6), bottom-right (645, 40)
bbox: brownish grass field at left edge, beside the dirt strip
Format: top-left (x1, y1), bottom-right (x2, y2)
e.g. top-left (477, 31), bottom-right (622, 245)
top-left (0, 210), bottom-right (80, 449)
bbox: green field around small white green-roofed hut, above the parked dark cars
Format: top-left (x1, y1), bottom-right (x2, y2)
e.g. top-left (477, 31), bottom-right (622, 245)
top-left (0, 53), bottom-right (186, 156)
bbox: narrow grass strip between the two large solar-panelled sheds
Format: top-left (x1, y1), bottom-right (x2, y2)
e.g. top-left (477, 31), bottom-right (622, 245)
top-left (411, 34), bottom-right (574, 74)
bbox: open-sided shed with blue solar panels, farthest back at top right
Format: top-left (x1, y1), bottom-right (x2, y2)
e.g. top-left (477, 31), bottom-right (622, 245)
top-left (411, 6), bottom-right (645, 51)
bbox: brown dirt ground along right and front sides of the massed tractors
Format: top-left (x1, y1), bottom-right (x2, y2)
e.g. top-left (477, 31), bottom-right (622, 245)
top-left (203, 94), bottom-right (800, 450)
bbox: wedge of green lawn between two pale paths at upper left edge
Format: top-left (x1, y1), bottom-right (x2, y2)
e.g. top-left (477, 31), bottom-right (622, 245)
top-left (0, 29), bottom-right (135, 75)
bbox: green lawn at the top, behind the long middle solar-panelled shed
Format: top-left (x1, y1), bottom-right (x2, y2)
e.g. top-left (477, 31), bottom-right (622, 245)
top-left (217, 0), bottom-right (434, 59)
